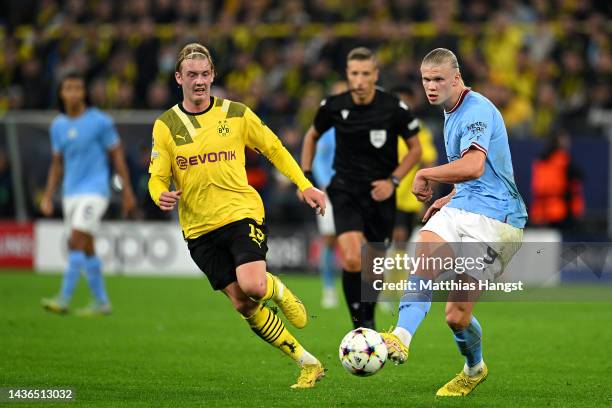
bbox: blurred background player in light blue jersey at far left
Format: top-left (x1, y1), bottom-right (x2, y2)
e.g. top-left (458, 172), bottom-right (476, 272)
top-left (40, 73), bottom-right (135, 315)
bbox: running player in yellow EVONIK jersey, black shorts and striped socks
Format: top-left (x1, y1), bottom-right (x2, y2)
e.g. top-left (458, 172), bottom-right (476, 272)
top-left (149, 43), bottom-right (325, 388)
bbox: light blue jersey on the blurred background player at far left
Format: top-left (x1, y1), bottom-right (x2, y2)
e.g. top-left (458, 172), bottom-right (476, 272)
top-left (50, 108), bottom-right (119, 197)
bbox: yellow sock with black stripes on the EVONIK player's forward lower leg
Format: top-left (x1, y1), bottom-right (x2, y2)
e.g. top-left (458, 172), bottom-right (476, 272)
top-left (246, 305), bottom-right (317, 365)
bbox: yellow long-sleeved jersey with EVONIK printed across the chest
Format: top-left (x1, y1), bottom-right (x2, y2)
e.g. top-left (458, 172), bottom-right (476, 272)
top-left (149, 97), bottom-right (312, 238)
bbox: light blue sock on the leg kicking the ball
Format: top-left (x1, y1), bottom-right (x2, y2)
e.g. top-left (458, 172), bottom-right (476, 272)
top-left (397, 275), bottom-right (432, 336)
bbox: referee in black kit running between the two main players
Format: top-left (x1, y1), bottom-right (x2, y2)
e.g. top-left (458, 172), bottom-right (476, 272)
top-left (302, 47), bottom-right (421, 328)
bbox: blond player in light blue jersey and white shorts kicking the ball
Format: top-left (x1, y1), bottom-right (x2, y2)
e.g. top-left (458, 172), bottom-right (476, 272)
top-left (382, 48), bottom-right (527, 396)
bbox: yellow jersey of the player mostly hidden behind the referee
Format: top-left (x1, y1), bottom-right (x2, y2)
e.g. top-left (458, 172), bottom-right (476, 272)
top-left (395, 123), bottom-right (438, 212)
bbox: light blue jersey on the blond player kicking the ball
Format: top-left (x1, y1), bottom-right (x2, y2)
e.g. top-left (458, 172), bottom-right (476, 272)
top-left (444, 89), bottom-right (527, 228)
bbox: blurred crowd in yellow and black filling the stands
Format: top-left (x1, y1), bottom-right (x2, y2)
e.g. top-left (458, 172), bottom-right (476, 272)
top-left (0, 0), bottom-right (612, 226)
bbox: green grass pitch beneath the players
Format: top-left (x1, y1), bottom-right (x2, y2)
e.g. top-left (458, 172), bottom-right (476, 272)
top-left (0, 272), bottom-right (612, 407)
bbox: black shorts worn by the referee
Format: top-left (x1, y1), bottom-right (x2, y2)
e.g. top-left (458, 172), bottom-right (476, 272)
top-left (327, 181), bottom-right (395, 244)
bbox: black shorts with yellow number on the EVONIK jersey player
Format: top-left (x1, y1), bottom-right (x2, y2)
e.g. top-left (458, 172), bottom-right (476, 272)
top-left (187, 218), bottom-right (268, 290)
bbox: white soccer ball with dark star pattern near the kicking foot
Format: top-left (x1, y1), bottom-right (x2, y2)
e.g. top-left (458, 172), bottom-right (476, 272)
top-left (338, 327), bottom-right (387, 377)
